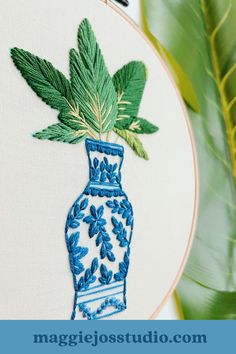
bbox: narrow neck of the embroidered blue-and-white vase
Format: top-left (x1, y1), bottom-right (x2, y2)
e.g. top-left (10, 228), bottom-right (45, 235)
top-left (85, 139), bottom-right (124, 188)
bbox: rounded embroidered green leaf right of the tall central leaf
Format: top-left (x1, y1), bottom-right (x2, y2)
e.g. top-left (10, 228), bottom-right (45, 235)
top-left (113, 61), bottom-right (147, 129)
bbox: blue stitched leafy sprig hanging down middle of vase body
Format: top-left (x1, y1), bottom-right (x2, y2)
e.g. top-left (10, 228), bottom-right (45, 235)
top-left (83, 205), bottom-right (116, 262)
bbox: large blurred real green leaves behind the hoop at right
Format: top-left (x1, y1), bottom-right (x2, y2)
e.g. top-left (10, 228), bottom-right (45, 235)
top-left (143, 0), bottom-right (236, 319)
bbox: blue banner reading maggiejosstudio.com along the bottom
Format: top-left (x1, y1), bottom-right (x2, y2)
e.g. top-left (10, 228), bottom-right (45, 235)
top-left (0, 321), bottom-right (236, 354)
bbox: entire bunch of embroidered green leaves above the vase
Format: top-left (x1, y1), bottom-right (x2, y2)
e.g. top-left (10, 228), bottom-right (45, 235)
top-left (11, 19), bottom-right (158, 160)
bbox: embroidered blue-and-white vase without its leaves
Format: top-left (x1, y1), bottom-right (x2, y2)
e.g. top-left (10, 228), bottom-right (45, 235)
top-left (65, 139), bottom-right (134, 320)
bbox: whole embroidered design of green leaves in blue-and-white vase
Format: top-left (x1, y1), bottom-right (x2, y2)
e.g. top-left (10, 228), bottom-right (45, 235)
top-left (11, 19), bottom-right (158, 320)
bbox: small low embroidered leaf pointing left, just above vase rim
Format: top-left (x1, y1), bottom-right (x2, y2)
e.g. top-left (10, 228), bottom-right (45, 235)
top-left (33, 123), bottom-right (86, 144)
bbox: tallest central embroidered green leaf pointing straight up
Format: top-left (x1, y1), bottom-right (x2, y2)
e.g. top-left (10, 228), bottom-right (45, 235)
top-left (70, 19), bottom-right (117, 136)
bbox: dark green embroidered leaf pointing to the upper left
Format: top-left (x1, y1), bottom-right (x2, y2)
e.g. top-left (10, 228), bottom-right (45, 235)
top-left (11, 48), bottom-right (73, 111)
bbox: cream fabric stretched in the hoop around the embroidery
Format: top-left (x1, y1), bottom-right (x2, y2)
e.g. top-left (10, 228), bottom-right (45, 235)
top-left (0, 0), bottom-right (195, 319)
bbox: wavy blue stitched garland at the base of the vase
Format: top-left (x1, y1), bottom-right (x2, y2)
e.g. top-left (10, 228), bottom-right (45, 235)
top-left (79, 297), bottom-right (126, 320)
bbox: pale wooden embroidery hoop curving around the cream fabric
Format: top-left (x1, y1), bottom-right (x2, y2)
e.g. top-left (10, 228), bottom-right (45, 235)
top-left (100, 0), bottom-right (199, 320)
